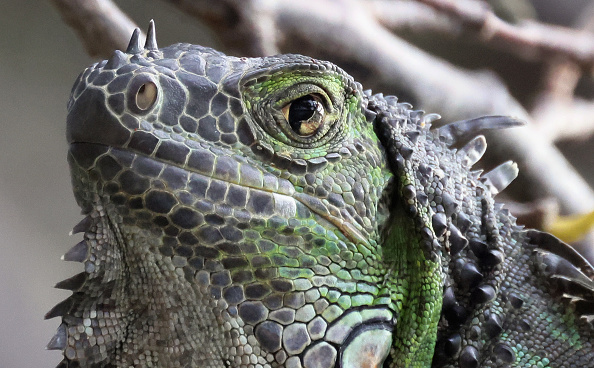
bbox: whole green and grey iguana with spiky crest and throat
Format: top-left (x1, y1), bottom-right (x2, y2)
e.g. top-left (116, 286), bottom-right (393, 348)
top-left (46, 22), bottom-right (594, 368)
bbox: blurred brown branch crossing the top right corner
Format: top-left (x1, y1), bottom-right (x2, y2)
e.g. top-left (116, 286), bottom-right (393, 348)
top-left (417, 0), bottom-right (594, 71)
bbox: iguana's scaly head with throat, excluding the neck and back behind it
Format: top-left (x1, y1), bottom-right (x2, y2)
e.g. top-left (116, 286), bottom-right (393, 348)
top-left (48, 20), bottom-right (395, 367)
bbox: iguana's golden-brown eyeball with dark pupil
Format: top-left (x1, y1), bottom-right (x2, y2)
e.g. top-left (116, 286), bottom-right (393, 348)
top-left (282, 94), bottom-right (326, 137)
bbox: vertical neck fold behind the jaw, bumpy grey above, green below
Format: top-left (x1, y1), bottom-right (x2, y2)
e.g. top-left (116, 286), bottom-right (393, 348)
top-left (368, 98), bottom-right (448, 367)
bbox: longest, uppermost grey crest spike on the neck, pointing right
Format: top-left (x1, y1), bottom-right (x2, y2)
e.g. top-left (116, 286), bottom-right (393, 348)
top-left (438, 115), bottom-right (525, 146)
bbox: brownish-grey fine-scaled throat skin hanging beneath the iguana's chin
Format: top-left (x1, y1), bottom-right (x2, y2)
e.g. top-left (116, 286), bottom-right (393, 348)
top-left (69, 152), bottom-right (237, 367)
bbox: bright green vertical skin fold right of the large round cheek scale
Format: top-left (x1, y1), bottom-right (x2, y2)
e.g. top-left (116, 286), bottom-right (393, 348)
top-left (384, 204), bottom-right (443, 368)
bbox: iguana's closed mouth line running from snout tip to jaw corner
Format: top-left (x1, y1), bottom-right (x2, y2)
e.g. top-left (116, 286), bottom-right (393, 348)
top-left (70, 141), bottom-right (369, 245)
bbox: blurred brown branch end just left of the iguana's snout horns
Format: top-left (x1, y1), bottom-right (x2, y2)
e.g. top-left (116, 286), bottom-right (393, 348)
top-left (52, 0), bottom-right (144, 58)
